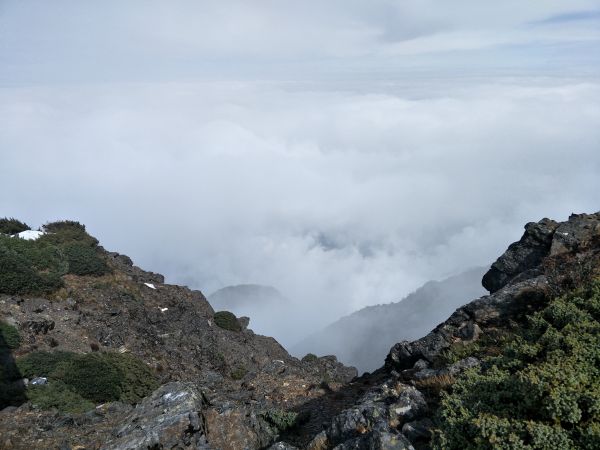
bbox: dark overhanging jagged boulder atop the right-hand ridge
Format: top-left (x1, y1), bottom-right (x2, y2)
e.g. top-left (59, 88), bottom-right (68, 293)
top-left (482, 219), bottom-right (558, 293)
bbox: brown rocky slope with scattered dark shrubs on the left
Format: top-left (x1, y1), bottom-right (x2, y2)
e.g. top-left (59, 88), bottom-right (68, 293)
top-left (0, 219), bottom-right (356, 449)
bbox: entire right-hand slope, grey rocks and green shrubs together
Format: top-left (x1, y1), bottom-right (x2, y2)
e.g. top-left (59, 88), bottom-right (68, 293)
top-left (285, 213), bottom-right (600, 450)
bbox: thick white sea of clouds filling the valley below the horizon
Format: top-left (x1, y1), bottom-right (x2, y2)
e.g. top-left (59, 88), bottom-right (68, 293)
top-left (0, 80), bottom-right (600, 343)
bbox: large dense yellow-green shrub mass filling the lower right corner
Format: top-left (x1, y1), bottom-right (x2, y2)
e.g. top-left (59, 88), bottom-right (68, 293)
top-left (433, 281), bottom-right (600, 449)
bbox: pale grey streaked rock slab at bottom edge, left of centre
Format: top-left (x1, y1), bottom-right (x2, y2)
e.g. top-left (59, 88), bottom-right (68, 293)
top-left (102, 382), bottom-right (209, 450)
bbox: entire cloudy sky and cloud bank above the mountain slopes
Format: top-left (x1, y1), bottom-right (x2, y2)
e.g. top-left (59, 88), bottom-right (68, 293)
top-left (0, 0), bottom-right (600, 345)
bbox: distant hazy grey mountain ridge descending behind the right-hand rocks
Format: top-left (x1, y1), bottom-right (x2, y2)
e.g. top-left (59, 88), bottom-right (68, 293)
top-left (291, 267), bottom-right (487, 371)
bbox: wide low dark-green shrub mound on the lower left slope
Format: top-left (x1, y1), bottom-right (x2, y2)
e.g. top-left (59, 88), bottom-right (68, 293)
top-left (17, 352), bottom-right (158, 410)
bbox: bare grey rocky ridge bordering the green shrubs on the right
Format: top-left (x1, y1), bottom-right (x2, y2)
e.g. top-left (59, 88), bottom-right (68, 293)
top-left (288, 213), bottom-right (600, 450)
